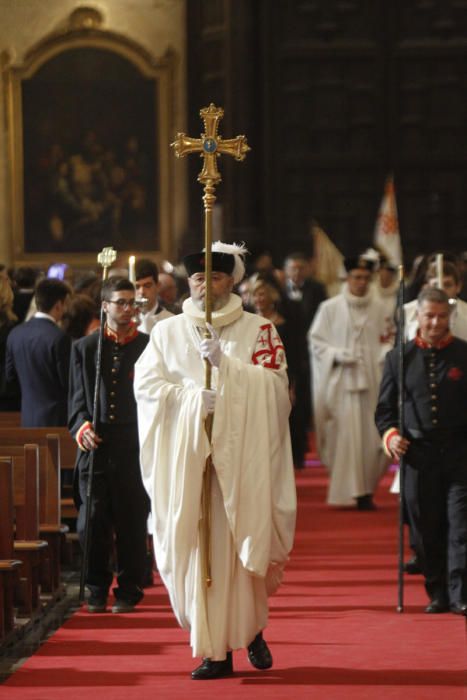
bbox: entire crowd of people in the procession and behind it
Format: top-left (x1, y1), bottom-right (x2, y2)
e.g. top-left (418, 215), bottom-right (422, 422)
top-left (0, 242), bottom-right (467, 680)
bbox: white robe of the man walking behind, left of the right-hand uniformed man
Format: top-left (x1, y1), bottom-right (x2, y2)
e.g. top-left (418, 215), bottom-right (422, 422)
top-left (308, 285), bottom-right (391, 505)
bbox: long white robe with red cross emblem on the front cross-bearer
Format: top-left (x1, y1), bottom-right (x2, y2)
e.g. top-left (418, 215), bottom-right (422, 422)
top-left (135, 295), bottom-right (296, 660)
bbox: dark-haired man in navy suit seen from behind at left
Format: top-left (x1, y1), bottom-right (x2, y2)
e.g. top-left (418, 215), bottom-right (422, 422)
top-left (5, 279), bottom-right (71, 428)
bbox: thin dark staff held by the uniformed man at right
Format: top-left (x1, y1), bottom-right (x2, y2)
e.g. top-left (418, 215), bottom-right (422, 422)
top-left (397, 265), bottom-right (405, 613)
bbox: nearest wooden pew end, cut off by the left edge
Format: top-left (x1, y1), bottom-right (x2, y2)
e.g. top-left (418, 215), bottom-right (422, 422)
top-left (0, 458), bottom-right (21, 645)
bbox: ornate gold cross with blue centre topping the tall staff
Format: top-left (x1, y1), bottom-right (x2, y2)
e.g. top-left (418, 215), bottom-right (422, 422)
top-left (170, 103), bottom-right (250, 185)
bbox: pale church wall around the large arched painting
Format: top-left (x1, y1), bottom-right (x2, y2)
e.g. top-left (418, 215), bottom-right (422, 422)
top-left (0, 0), bottom-right (187, 264)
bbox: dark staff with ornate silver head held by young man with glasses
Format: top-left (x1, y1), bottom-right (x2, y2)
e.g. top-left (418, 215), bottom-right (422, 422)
top-left (79, 247), bottom-right (117, 603)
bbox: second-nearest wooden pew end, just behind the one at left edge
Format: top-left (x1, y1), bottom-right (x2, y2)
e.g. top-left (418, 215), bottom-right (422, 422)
top-left (11, 445), bottom-right (49, 616)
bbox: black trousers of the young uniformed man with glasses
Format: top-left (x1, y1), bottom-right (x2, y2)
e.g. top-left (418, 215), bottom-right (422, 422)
top-left (77, 425), bottom-right (149, 604)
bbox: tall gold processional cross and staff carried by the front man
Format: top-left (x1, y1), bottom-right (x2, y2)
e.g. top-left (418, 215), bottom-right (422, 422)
top-left (170, 103), bottom-right (250, 588)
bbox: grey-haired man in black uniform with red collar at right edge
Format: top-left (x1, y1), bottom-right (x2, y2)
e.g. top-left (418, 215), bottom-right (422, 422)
top-left (376, 288), bottom-right (467, 615)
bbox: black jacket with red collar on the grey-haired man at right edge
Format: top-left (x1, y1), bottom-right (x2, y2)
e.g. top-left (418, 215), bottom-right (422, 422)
top-left (375, 336), bottom-right (467, 438)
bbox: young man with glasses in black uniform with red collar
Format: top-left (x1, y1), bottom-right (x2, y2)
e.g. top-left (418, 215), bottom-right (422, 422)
top-left (68, 277), bottom-right (149, 613)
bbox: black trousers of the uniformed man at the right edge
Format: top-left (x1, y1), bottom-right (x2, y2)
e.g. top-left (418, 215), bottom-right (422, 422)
top-left (404, 436), bottom-right (467, 604)
